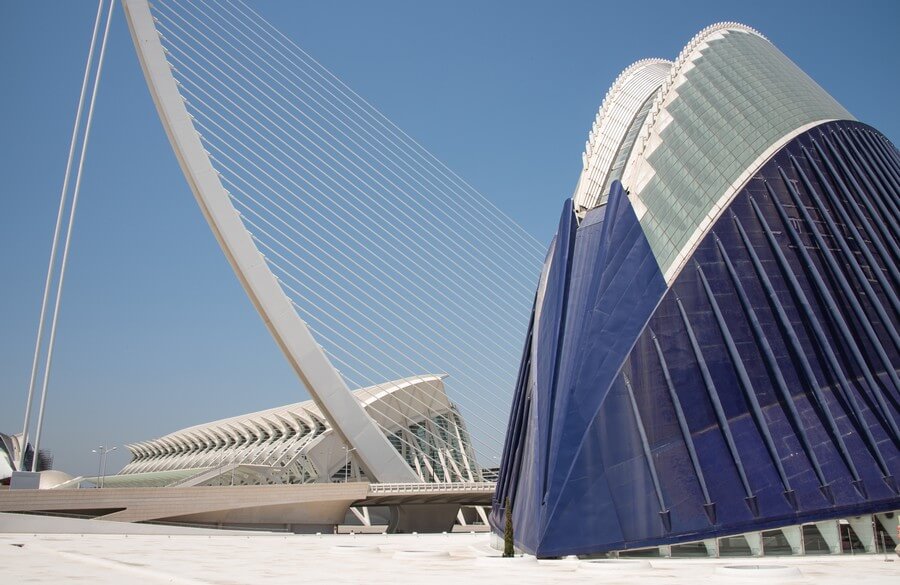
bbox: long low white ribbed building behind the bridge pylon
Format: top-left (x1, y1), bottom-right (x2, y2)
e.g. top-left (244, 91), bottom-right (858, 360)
top-left (119, 375), bottom-right (481, 486)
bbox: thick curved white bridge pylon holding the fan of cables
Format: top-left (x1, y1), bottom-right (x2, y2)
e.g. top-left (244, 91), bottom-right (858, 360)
top-left (122, 0), bottom-right (420, 482)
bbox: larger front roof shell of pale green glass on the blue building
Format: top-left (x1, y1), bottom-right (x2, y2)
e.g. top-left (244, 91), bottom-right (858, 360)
top-left (622, 23), bottom-right (854, 282)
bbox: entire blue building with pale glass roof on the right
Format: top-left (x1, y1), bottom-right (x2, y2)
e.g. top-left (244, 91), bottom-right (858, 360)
top-left (491, 23), bottom-right (900, 557)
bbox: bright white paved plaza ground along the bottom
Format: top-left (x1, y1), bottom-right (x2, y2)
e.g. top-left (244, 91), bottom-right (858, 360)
top-left (0, 534), bottom-right (900, 585)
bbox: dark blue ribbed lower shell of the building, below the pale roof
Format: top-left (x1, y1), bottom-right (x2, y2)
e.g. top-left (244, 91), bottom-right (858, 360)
top-left (491, 121), bottom-right (900, 556)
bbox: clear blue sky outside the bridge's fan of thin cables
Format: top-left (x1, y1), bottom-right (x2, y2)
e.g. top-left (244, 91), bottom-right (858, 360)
top-left (0, 0), bottom-right (900, 473)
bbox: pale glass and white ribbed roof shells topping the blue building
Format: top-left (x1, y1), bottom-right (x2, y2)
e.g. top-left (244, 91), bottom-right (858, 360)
top-left (573, 22), bottom-right (854, 283)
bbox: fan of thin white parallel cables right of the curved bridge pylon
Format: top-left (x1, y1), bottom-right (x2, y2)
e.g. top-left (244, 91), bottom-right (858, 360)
top-left (151, 0), bottom-right (544, 474)
